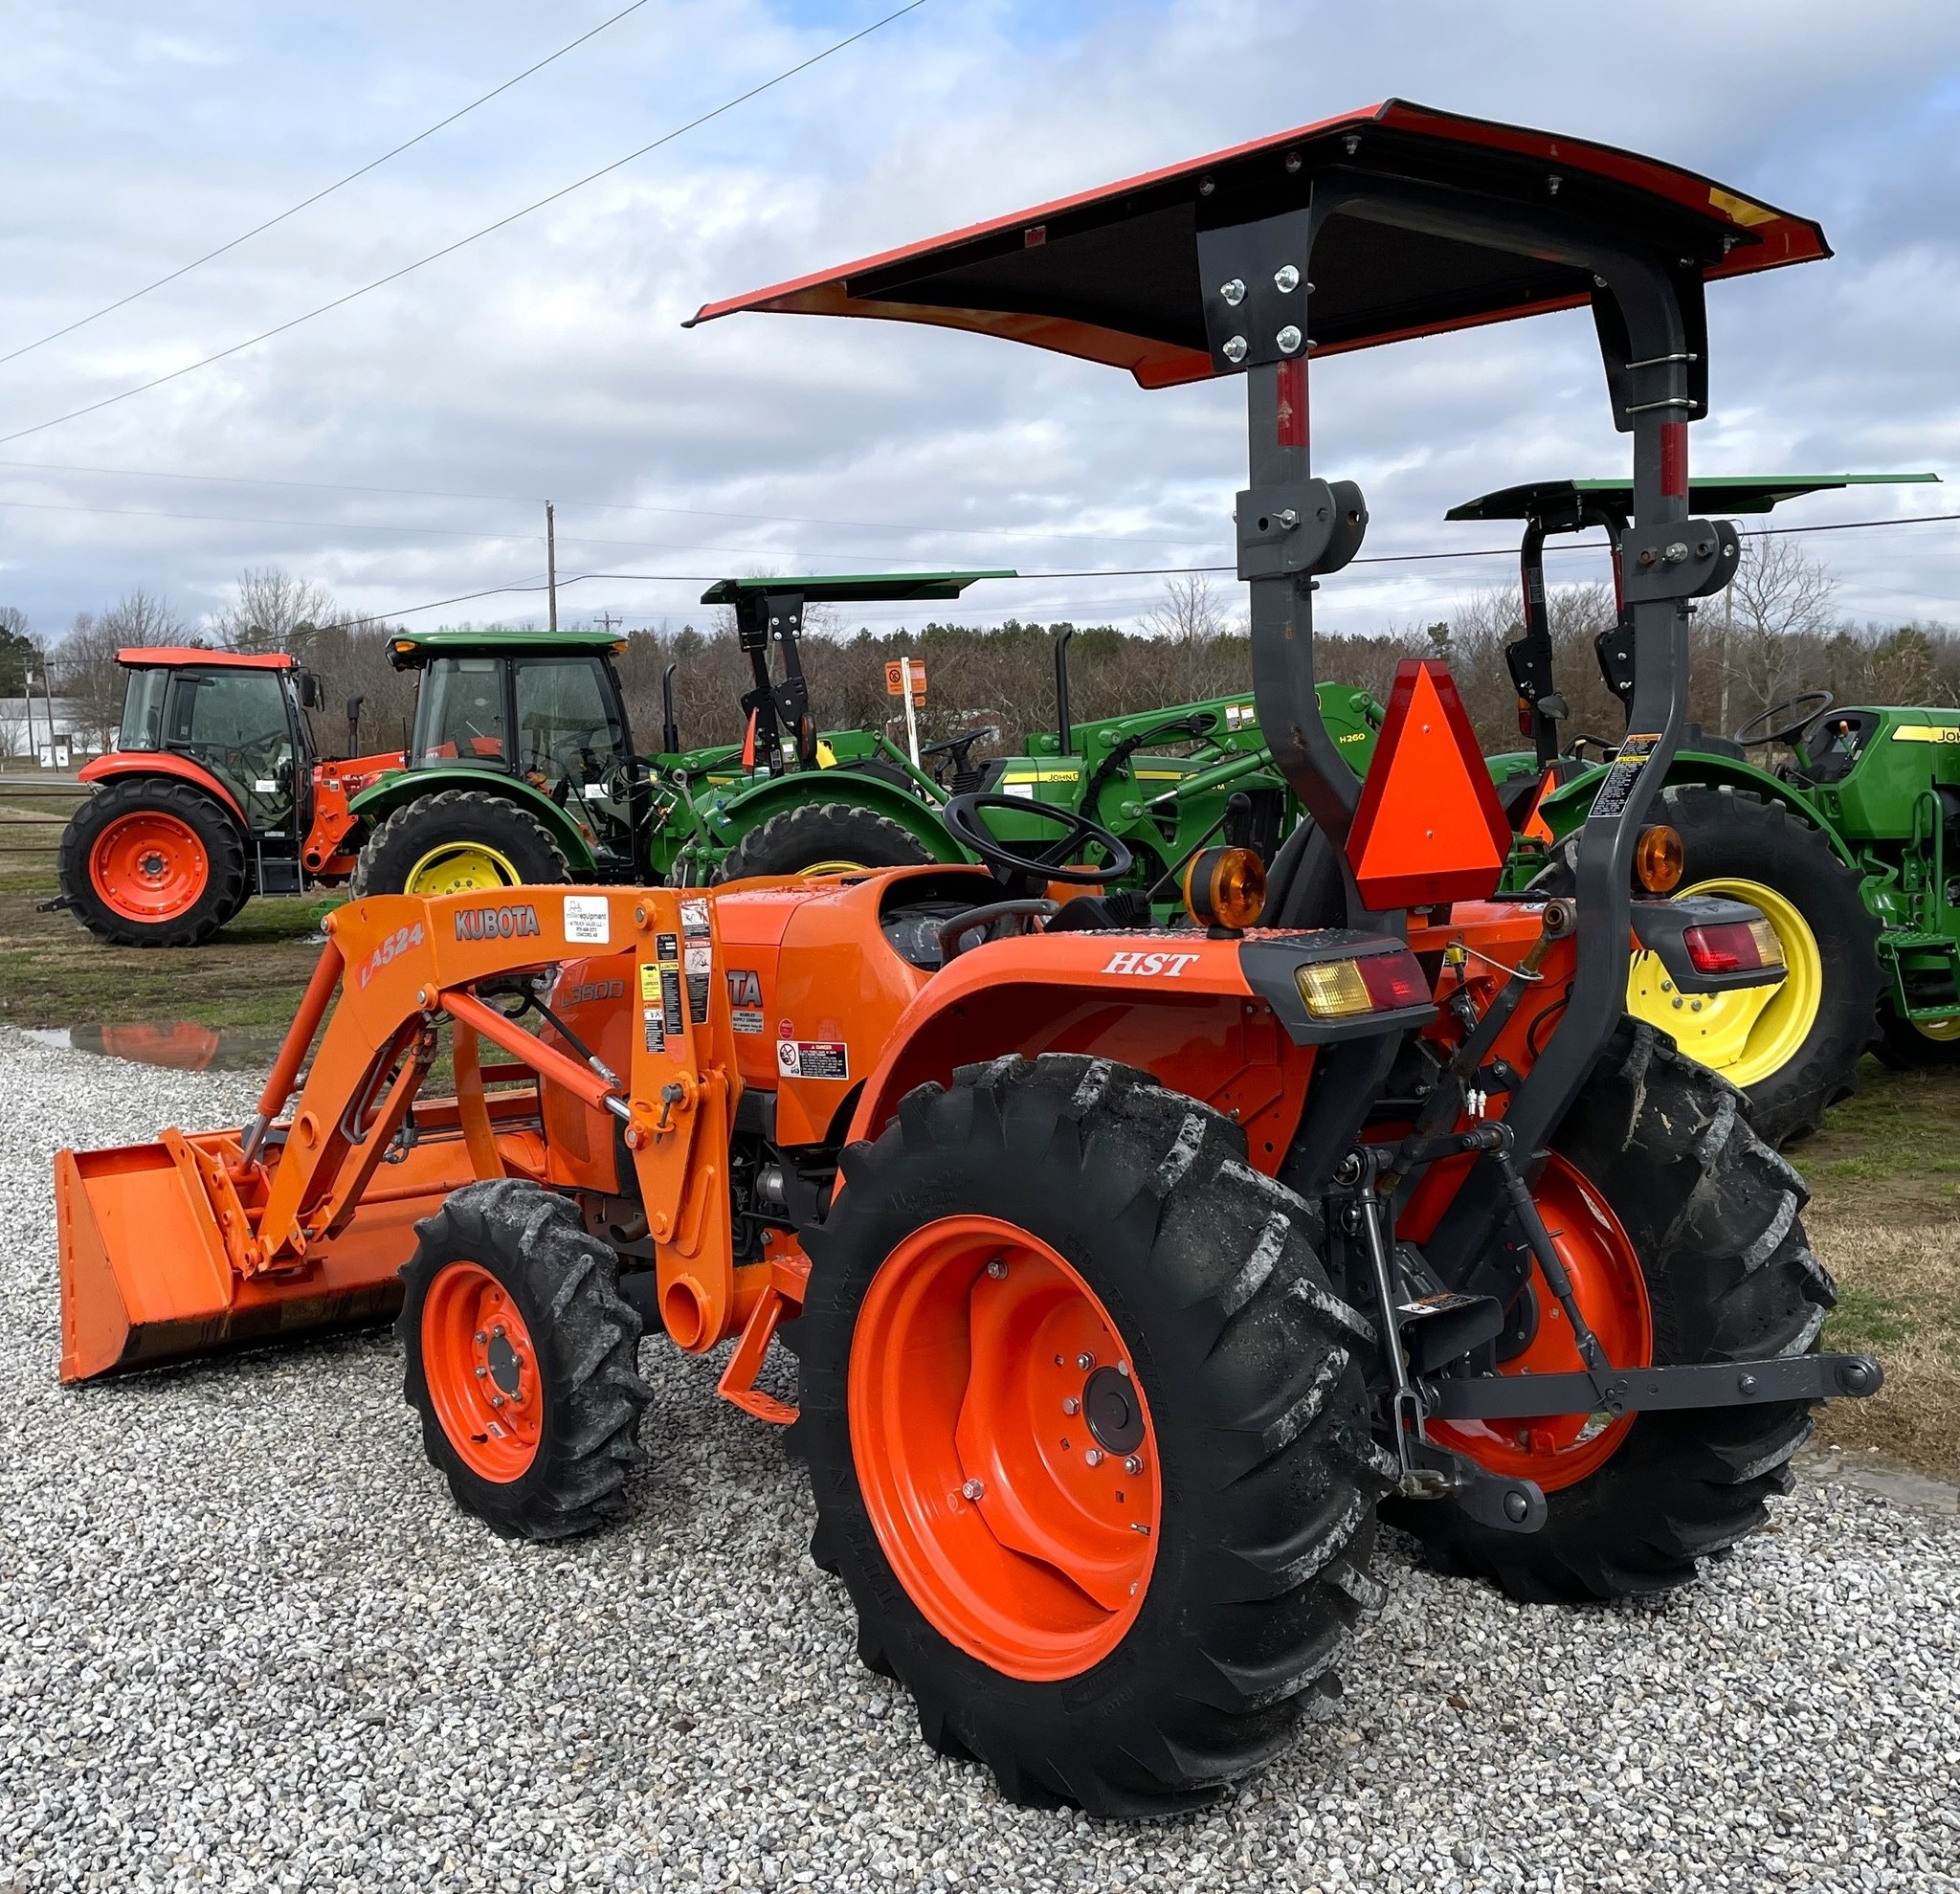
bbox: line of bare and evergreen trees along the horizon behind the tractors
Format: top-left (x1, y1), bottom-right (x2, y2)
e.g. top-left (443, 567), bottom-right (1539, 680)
top-left (15, 539), bottom-right (1960, 755)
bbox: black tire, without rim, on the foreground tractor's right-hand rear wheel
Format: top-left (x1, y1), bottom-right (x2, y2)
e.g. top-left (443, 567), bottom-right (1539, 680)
top-left (1388, 1019), bottom-right (1837, 1604)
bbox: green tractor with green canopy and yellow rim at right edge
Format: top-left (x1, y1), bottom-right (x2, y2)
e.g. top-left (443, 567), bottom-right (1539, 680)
top-left (1325, 475), bottom-right (1936, 1143)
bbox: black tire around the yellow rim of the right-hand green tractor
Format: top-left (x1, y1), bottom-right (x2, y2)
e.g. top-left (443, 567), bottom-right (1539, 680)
top-left (1533, 782), bottom-right (1883, 1145)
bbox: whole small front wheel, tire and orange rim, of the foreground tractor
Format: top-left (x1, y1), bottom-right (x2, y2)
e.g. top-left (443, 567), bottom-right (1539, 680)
top-left (396, 1178), bottom-right (653, 1539)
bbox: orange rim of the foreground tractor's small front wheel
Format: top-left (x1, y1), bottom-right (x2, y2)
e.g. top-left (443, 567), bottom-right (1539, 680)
top-left (421, 1262), bottom-right (545, 1484)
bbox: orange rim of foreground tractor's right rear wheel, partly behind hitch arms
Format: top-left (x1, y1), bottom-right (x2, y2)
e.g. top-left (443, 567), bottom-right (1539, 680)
top-left (1429, 1153), bottom-right (1655, 1492)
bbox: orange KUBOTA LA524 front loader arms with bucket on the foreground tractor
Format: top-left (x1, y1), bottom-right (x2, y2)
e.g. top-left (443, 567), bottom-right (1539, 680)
top-left (56, 888), bottom-right (752, 1380)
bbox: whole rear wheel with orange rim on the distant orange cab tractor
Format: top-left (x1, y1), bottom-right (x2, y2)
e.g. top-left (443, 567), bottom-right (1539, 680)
top-left (55, 776), bottom-right (251, 947)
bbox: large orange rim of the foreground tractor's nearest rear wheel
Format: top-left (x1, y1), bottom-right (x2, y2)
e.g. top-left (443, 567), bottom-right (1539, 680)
top-left (849, 1215), bottom-right (1162, 1682)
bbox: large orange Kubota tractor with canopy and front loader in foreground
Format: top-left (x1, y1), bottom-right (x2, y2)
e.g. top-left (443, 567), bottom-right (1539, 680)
top-left (56, 104), bottom-right (1880, 1814)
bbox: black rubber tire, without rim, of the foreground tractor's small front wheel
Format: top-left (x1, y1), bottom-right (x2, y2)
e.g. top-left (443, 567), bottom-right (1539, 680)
top-left (396, 1178), bottom-right (653, 1539)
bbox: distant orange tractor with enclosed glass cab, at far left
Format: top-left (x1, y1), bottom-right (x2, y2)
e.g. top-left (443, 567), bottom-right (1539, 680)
top-left (49, 645), bottom-right (402, 947)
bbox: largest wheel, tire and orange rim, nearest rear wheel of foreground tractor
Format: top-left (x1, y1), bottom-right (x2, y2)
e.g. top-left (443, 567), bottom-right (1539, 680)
top-left (784, 1055), bottom-right (1393, 1816)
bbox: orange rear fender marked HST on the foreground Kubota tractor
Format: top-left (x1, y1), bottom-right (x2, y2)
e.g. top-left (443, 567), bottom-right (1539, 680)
top-left (849, 929), bottom-right (1433, 1174)
